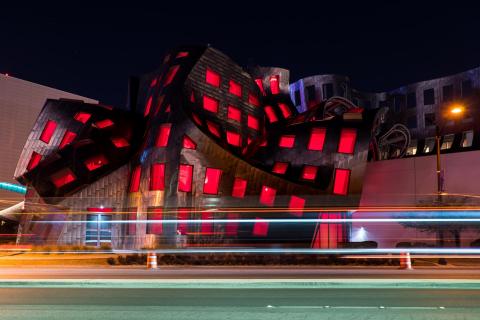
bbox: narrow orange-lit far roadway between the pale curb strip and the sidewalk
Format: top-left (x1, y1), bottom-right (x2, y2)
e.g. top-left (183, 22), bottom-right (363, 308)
top-left (0, 267), bottom-right (480, 278)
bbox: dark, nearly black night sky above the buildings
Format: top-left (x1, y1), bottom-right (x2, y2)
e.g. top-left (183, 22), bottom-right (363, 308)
top-left (0, 0), bottom-right (480, 105)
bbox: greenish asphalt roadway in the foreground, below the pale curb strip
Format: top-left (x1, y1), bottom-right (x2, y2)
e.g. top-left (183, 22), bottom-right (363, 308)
top-left (0, 288), bottom-right (480, 320)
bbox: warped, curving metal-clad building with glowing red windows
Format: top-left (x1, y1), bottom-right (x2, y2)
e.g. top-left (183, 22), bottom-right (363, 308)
top-left (8, 46), bottom-right (480, 248)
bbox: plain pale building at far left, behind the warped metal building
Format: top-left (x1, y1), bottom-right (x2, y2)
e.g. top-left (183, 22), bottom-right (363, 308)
top-left (0, 74), bottom-right (98, 210)
